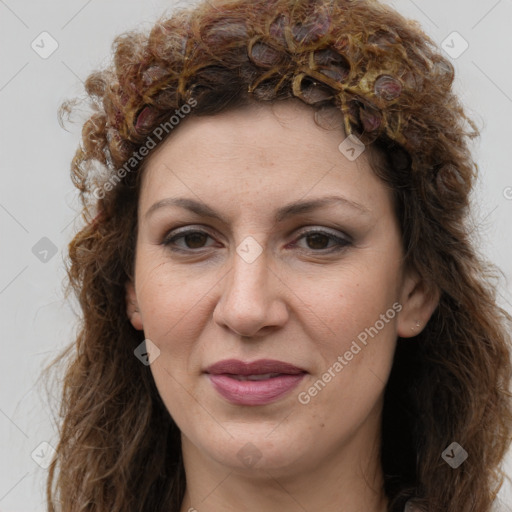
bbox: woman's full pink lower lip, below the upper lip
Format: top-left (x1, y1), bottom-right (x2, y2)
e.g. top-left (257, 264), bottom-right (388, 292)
top-left (208, 373), bottom-right (306, 405)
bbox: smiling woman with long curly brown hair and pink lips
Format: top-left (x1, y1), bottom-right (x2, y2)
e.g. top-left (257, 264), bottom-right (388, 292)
top-left (47, 0), bottom-right (512, 512)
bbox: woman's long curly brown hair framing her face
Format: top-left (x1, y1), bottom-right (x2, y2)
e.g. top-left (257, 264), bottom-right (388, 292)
top-left (47, 0), bottom-right (512, 512)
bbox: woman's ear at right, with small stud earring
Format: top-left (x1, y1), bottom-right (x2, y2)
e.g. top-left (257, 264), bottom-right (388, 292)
top-left (397, 270), bottom-right (440, 338)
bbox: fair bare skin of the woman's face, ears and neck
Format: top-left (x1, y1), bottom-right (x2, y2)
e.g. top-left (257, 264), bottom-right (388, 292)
top-left (126, 99), bottom-right (436, 512)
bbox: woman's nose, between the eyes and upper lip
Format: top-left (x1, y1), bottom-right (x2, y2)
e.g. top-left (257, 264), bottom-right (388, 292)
top-left (213, 244), bottom-right (288, 337)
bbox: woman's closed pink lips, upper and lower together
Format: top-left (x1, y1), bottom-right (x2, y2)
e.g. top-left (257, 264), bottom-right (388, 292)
top-left (205, 359), bottom-right (306, 405)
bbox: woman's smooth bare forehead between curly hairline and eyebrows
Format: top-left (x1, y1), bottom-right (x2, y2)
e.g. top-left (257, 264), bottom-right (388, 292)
top-left (136, 99), bottom-right (392, 218)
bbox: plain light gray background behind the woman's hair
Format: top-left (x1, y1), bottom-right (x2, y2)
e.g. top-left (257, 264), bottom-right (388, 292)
top-left (0, 0), bottom-right (512, 512)
